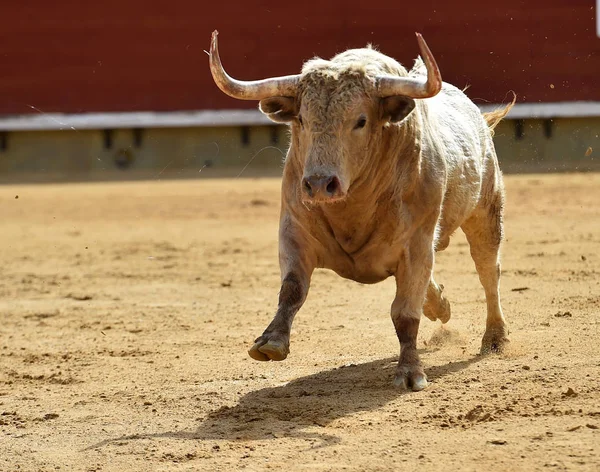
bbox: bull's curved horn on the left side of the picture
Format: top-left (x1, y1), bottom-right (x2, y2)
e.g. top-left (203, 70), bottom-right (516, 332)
top-left (209, 30), bottom-right (300, 100)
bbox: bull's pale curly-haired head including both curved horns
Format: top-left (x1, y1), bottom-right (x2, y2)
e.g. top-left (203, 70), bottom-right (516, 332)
top-left (210, 31), bottom-right (442, 203)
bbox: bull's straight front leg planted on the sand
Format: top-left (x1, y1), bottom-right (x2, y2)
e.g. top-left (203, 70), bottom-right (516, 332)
top-left (392, 233), bottom-right (434, 391)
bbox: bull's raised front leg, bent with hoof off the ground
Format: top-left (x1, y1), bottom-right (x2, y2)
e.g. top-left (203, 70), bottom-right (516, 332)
top-left (248, 235), bottom-right (314, 361)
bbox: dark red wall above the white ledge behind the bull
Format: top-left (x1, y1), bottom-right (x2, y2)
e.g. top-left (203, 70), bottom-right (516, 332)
top-left (0, 0), bottom-right (600, 114)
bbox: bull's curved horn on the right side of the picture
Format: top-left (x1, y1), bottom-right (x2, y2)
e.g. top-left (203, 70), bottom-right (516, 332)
top-left (377, 33), bottom-right (442, 98)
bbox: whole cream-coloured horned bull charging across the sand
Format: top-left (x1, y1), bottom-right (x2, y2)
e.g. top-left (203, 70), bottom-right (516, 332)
top-left (210, 31), bottom-right (514, 391)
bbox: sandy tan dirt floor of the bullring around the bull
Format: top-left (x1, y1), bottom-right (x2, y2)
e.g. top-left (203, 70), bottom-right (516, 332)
top-left (0, 174), bottom-right (600, 471)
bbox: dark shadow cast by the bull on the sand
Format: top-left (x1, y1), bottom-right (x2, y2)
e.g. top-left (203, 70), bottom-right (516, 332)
top-left (88, 356), bottom-right (481, 449)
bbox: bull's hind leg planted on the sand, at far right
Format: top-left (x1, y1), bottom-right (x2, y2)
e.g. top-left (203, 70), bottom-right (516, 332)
top-left (461, 185), bottom-right (508, 354)
